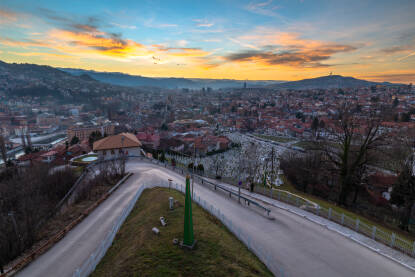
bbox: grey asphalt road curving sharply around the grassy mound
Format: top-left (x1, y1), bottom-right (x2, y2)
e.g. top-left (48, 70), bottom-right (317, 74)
top-left (17, 160), bottom-right (415, 277)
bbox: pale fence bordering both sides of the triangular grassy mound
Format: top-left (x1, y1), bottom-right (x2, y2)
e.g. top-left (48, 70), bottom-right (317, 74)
top-left (72, 182), bottom-right (284, 277)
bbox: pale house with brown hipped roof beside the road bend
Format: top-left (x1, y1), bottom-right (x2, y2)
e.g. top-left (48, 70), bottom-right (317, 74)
top-left (93, 133), bottom-right (141, 160)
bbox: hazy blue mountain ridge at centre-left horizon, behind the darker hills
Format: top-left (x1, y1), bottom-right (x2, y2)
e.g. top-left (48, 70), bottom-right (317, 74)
top-left (60, 68), bottom-right (281, 89)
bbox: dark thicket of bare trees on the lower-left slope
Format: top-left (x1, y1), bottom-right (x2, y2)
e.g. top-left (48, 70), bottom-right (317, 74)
top-left (0, 164), bottom-right (76, 263)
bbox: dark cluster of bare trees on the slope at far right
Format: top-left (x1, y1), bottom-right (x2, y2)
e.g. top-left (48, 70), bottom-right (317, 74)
top-left (281, 105), bottom-right (415, 231)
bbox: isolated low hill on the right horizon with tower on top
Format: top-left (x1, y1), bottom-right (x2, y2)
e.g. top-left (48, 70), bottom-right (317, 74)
top-left (267, 75), bottom-right (400, 90)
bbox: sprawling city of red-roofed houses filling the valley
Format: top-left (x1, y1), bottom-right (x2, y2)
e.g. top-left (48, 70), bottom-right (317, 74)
top-left (0, 63), bottom-right (415, 209)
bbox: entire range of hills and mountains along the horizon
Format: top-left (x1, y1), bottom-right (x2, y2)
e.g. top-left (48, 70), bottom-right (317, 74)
top-left (0, 61), bottom-right (401, 93)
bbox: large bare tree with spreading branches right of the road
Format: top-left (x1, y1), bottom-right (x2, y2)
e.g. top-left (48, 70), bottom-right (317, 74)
top-left (317, 107), bottom-right (386, 205)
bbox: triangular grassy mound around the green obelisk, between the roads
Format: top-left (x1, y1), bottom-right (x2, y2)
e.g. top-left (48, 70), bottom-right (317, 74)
top-left (91, 188), bottom-right (272, 277)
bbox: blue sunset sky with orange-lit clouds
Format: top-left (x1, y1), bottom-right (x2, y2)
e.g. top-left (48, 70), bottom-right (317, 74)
top-left (0, 0), bottom-right (415, 83)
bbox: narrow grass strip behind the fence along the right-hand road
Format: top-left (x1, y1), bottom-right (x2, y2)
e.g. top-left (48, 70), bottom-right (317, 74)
top-left (278, 176), bottom-right (415, 243)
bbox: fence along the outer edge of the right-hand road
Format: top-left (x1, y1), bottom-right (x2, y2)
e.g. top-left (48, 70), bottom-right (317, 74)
top-left (135, 156), bottom-right (415, 257)
